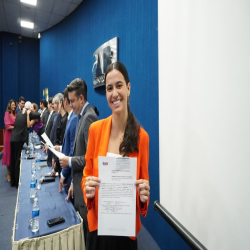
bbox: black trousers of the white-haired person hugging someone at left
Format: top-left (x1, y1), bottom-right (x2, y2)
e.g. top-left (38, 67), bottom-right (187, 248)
top-left (10, 142), bottom-right (23, 187)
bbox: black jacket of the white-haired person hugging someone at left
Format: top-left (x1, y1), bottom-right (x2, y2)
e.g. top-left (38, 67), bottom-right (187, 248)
top-left (10, 111), bottom-right (40, 143)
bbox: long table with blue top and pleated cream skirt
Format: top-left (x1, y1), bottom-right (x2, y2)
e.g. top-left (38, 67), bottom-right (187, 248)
top-left (12, 150), bottom-right (85, 250)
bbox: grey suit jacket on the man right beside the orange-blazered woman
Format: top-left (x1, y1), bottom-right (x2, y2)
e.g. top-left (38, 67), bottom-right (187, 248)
top-left (71, 104), bottom-right (97, 209)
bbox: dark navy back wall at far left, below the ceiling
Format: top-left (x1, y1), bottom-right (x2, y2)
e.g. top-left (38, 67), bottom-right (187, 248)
top-left (0, 32), bottom-right (40, 128)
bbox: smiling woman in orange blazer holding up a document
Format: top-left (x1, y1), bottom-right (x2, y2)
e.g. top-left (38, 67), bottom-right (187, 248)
top-left (81, 62), bottom-right (150, 250)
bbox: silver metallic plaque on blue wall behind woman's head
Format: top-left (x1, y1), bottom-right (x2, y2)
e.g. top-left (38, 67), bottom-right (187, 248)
top-left (92, 37), bottom-right (118, 88)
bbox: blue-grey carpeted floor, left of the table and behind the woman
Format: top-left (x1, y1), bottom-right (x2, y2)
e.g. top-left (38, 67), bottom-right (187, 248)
top-left (0, 160), bottom-right (160, 250)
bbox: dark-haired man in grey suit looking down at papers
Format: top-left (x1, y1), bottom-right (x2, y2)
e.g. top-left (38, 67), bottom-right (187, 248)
top-left (59, 78), bottom-right (97, 242)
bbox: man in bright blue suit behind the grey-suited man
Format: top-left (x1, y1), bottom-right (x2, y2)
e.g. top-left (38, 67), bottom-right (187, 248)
top-left (52, 88), bottom-right (78, 193)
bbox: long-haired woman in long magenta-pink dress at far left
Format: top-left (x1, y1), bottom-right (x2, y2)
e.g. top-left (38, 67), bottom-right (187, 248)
top-left (2, 99), bottom-right (16, 182)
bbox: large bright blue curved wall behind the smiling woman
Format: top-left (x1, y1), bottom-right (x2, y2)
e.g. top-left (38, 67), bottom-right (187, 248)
top-left (40, 0), bottom-right (188, 249)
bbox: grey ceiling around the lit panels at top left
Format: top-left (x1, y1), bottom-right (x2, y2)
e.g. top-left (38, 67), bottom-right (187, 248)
top-left (0, 0), bottom-right (82, 38)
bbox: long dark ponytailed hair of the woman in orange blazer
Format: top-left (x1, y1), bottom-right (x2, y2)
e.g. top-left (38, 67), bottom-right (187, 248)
top-left (105, 62), bottom-right (140, 156)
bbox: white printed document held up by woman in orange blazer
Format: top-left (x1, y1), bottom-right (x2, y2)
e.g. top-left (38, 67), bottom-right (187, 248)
top-left (98, 156), bottom-right (137, 236)
